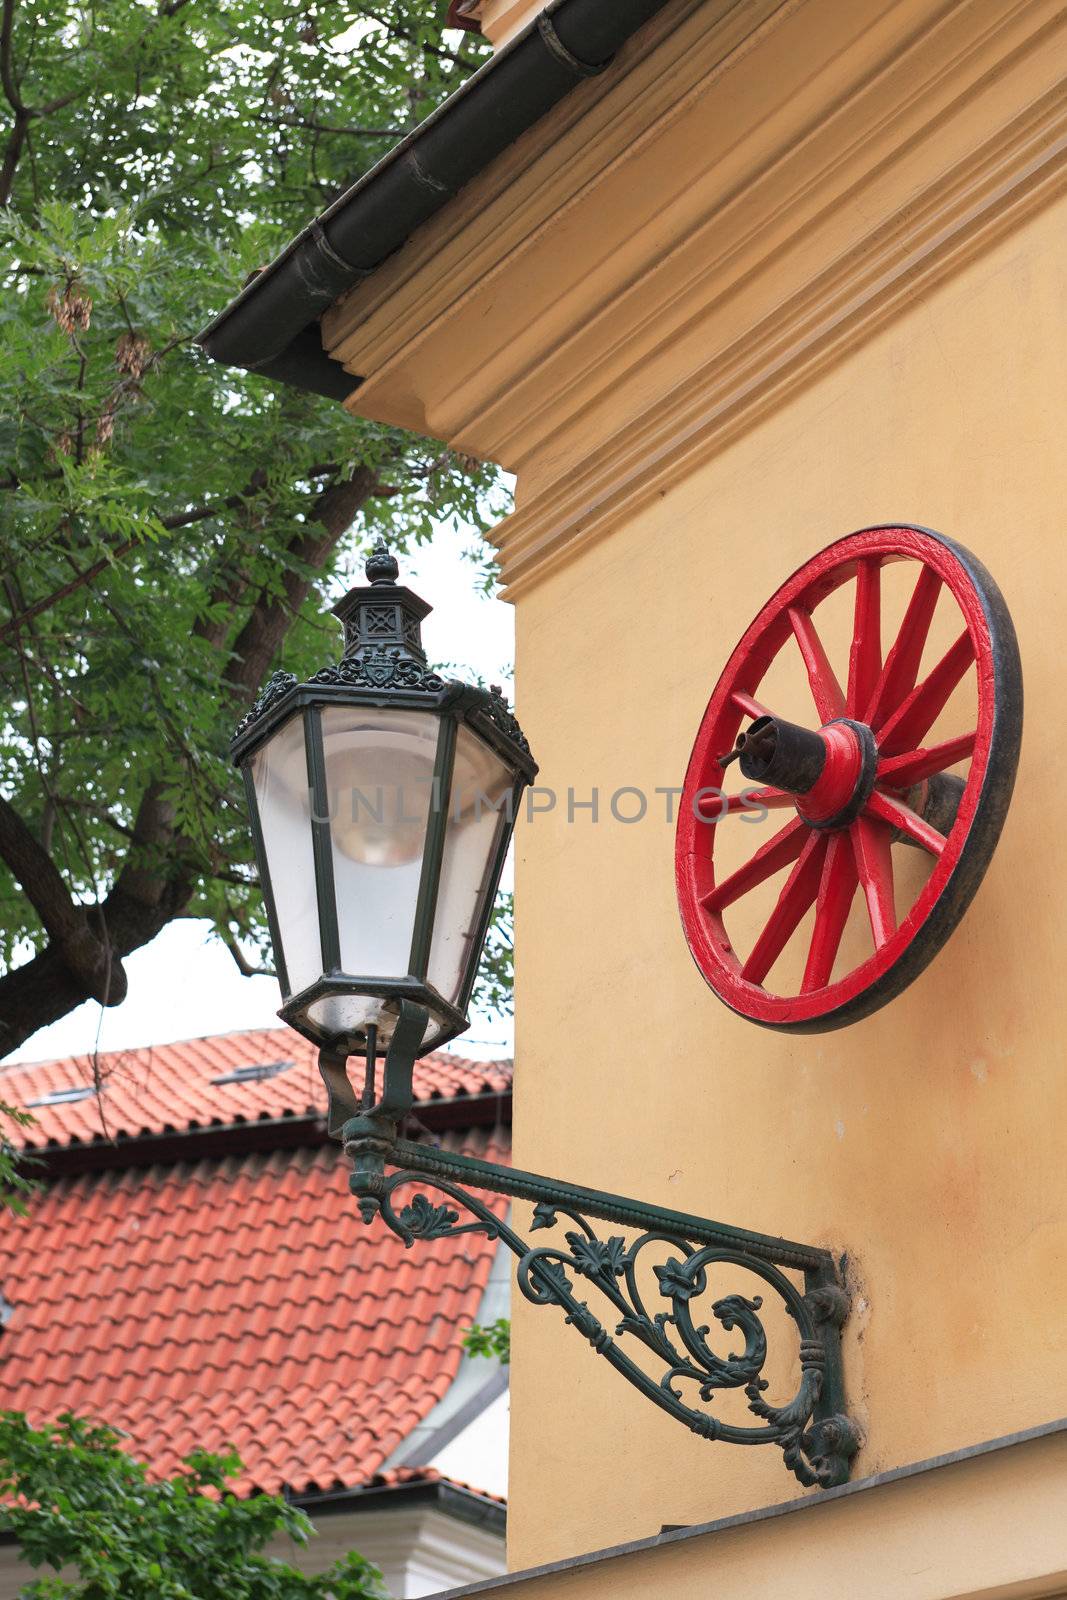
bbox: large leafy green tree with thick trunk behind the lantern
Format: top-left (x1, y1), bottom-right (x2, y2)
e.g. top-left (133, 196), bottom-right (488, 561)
top-left (0, 0), bottom-right (508, 1054)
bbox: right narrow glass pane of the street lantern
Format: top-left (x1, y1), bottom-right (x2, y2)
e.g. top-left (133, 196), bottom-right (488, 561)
top-left (427, 723), bottom-right (515, 1005)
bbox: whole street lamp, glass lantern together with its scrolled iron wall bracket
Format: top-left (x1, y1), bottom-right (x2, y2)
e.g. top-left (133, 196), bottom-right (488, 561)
top-left (234, 542), bottom-right (859, 1488)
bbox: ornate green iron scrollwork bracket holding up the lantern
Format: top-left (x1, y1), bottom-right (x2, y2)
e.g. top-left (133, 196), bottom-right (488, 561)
top-left (320, 1002), bottom-right (859, 1488)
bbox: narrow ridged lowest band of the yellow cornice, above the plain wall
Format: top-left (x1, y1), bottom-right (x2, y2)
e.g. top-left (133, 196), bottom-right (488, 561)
top-left (493, 75), bottom-right (1067, 600)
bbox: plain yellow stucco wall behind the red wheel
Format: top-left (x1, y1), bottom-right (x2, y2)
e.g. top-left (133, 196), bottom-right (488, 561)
top-left (509, 184), bottom-right (1067, 1566)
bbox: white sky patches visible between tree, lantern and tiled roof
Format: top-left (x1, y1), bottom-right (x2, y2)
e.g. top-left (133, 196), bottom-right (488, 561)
top-left (10, 530), bottom-right (515, 1061)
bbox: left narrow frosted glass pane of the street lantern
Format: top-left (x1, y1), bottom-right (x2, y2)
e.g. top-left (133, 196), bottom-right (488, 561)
top-left (251, 715), bottom-right (322, 994)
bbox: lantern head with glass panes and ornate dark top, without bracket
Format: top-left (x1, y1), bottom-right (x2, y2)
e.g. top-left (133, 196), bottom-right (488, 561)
top-left (232, 541), bottom-right (537, 1059)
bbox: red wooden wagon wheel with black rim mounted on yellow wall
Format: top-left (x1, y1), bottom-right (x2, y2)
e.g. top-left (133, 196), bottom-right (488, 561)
top-left (675, 526), bottom-right (1022, 1032)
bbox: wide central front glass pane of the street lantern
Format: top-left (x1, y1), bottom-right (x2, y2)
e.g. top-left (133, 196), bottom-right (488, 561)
top-left (322, 706), bottom-right (438, 978)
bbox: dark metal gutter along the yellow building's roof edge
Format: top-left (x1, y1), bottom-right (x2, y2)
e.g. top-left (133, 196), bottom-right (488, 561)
top-left (197, 0), bottom-right (667, 400)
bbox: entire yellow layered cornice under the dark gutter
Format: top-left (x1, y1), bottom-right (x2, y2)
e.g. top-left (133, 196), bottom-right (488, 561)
top-left (323, 0), bottom-right (1067, 597)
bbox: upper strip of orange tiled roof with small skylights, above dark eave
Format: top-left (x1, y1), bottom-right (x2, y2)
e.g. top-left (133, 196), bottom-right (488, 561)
top-left (0, 1027), bottom-right (512, 1146)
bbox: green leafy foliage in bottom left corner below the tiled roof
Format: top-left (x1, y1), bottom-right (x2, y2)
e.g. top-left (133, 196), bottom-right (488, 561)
top-left (0, 1411), bottom-right (386, 1600)
